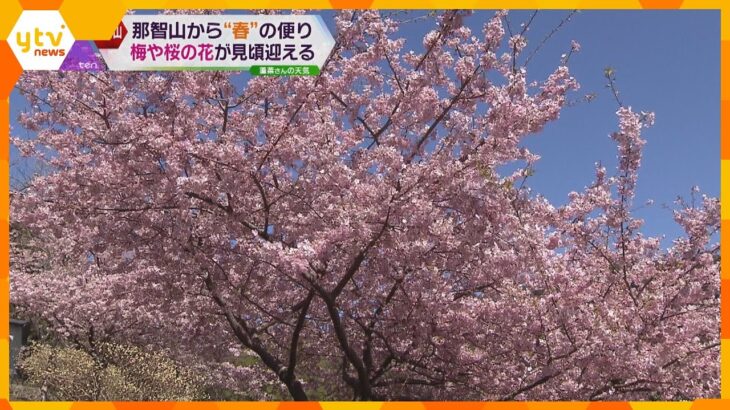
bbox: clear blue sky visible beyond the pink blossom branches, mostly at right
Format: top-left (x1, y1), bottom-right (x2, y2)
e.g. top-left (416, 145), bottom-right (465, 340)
top-left (11, 10), bottom-right (720, 245)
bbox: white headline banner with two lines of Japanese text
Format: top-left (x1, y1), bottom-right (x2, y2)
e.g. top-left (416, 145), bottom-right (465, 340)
top-left (97, 15), bottom-right (335, 75)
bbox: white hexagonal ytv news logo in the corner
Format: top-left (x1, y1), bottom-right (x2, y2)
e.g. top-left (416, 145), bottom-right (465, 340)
top-left (8, 10), bottom-right (74, 70)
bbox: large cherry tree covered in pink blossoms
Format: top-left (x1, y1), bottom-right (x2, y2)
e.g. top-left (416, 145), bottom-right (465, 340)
top-left (11, 11), bottom-right (720, 400)
